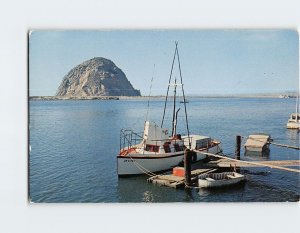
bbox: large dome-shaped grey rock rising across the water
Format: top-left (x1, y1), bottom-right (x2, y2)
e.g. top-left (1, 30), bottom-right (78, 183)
top-left (56, 57), bottom-right (141, 97)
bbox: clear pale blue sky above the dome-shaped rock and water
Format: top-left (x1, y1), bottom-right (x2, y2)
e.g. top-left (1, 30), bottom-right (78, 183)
top-left (29, 29), bottom-right (299, 96)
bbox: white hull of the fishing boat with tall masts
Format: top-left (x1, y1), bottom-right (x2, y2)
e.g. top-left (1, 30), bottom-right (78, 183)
top-left (117, 145), bottom-right (221, 177)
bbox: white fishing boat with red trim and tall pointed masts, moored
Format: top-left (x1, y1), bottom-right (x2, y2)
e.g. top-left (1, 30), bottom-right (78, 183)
top-left (117, 43), bottom-right (222, 177)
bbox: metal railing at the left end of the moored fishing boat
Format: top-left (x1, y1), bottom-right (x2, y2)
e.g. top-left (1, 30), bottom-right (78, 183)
top-left (120, 129), bottom-right (143, 150)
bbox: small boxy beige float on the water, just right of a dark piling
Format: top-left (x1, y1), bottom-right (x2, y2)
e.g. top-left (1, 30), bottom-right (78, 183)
top-left (244, 134), bottom-right (271, 153)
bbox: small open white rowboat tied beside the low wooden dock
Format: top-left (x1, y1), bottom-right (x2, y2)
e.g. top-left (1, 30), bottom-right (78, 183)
top-left (198, 172), bottom-right (245, 188)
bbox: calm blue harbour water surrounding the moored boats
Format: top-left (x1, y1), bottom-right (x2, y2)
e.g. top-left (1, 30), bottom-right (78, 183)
top-left (29, 98), bottom-right (300, 202)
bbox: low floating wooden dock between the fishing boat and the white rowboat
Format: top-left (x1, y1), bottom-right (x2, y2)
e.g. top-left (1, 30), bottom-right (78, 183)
top-left (147, 168), bottom-right (217, 189)
